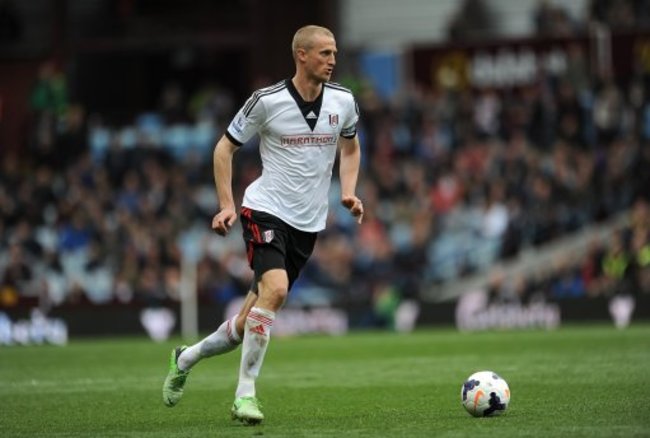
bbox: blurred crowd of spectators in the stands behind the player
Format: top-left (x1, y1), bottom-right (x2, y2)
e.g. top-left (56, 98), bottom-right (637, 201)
top-left (0, 4), bottom-right (650, 317)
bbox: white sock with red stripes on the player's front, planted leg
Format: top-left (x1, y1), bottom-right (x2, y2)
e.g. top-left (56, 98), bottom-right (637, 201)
top-left (235, 307), bottom-right (275, 398)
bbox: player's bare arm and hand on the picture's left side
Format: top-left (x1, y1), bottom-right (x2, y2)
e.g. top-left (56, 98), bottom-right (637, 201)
top-left (212, 135), bottom-right (239, 236)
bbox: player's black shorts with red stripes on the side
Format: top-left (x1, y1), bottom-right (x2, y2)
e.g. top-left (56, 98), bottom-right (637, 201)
top-left (241, 207), bottom-right (318, 293)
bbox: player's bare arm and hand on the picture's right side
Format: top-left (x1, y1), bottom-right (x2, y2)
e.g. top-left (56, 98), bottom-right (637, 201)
top-left (339, 135), bottom-right (363, 223)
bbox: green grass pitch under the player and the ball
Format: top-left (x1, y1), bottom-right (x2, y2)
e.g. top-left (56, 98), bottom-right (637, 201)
top-left (0, 324), bottom-right (650, 437)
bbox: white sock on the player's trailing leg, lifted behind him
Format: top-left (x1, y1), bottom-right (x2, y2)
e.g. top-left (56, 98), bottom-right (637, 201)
top-left (178, 315), bottom-right (241, 371)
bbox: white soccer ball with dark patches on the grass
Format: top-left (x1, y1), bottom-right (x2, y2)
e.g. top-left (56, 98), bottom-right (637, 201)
top-left (460, 371), bottom-right (510, 417)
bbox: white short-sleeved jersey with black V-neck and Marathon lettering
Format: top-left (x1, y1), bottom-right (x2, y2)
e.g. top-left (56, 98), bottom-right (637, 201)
top-left (226, 79), bottom-right (359, 232)
